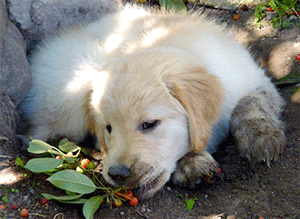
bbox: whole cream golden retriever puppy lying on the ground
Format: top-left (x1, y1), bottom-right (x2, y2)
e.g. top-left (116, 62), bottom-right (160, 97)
top-left (21, 6), bottom-right (285, 198)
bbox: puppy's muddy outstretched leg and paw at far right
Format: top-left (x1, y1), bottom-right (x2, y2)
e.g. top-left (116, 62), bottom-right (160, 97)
top-left (231, 84), bottom-right (286, 166)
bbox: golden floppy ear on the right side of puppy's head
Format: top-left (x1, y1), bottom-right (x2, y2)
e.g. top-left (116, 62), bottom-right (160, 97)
top-left (163, 67), bottom-right (223, 151)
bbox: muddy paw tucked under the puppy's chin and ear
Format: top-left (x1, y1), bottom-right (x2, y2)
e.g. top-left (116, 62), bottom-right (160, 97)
top-left (171, 151), bottom-right (219, 188)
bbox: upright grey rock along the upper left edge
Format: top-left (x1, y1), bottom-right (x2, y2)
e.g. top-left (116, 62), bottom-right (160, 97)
top-left (0, 0), bottom-right (31, 105)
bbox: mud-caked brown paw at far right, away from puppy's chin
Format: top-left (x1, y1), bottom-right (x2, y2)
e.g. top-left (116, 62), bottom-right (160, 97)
top-left (234, 119), bottom-right (286, 166)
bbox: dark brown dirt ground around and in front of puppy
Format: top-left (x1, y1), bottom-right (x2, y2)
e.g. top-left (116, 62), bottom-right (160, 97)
top-left (0, 3), bottom-right (300, 219)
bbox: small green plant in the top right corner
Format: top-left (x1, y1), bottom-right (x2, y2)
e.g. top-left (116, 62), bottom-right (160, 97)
top-left (254, 0), bottom-right (300, 29)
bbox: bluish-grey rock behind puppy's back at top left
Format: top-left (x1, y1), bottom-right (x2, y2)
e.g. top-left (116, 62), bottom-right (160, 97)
top-left (7, 0), bottom-right (122, 43)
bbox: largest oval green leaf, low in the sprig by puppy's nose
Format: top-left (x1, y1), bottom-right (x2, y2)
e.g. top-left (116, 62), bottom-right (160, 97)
top-left (47, 170), bottom-right (97, 194)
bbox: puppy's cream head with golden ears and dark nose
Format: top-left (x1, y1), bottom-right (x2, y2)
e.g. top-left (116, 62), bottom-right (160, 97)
top-left (91, 50), bottom-right (222, 198)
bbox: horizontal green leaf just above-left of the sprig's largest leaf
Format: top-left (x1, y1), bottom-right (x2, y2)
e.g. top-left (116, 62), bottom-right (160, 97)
top-left (25, 158), bottom-right (63, 173)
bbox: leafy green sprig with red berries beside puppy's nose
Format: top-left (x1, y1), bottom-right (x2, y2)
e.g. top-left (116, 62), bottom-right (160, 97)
top-left (17, 139), bottom-right (139, 219)
